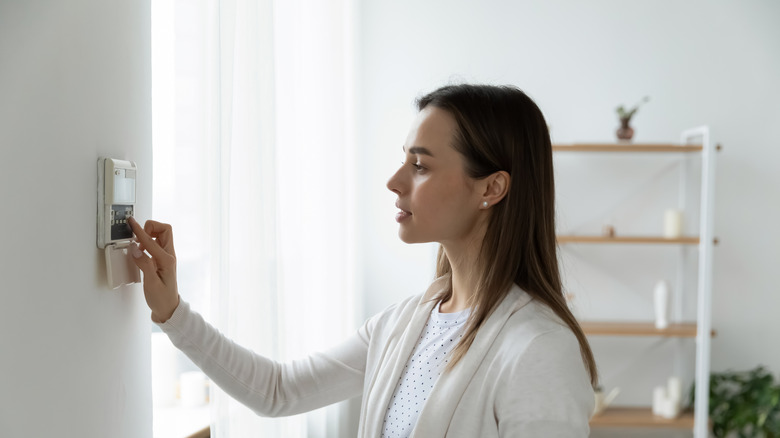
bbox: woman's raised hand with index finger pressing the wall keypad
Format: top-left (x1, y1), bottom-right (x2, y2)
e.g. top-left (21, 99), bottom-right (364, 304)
top-left (128, 217), bottom-right (179, 323)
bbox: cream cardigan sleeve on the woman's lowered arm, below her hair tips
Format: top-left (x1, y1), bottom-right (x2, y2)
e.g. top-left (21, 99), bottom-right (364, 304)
top-left (494, 327), bottom-right (594, 438)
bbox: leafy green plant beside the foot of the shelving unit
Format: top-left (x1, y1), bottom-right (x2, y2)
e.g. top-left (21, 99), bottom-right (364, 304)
top-left (689, 366), bottom-right (780, 438)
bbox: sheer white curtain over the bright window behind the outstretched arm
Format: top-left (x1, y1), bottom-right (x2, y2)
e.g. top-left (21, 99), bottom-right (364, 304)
top-left (153, 0), bottom-right (361, 438)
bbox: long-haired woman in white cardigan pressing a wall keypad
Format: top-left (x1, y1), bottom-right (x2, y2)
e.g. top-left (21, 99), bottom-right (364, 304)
top-left (131, 85), bottom-right (597, 438)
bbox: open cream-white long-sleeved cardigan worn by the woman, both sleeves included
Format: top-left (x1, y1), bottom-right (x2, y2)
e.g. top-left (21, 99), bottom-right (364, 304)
top-left (160, 277), bottom-right (594, 438)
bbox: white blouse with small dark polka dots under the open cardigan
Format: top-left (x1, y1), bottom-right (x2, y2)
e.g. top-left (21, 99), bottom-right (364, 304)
top-left (382, 305), bottom-right (469, 438)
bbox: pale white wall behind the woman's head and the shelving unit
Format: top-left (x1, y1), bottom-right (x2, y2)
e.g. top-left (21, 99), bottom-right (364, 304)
top-left (357, 0), bottom-right (780, 434)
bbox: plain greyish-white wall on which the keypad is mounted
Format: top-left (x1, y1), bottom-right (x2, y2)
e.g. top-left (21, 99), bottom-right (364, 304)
top-left (0, 0), bottom-right (152, 438)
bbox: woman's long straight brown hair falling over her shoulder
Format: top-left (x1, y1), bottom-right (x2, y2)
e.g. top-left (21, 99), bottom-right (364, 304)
top-left (417, 84), bottom-right (598, 387)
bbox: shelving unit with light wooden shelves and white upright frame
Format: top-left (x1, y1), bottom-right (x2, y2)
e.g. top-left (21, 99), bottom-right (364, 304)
top-left (553, 130), bottom-right (720, 438)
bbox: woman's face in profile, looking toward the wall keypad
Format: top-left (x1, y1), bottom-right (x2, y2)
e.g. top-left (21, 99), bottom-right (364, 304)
top-left (387, 106), bottom-right (482, 246)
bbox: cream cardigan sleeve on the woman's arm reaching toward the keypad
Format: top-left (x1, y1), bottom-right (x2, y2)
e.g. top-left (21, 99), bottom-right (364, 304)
top-left (159, 301), bottom-right (371, 417)
